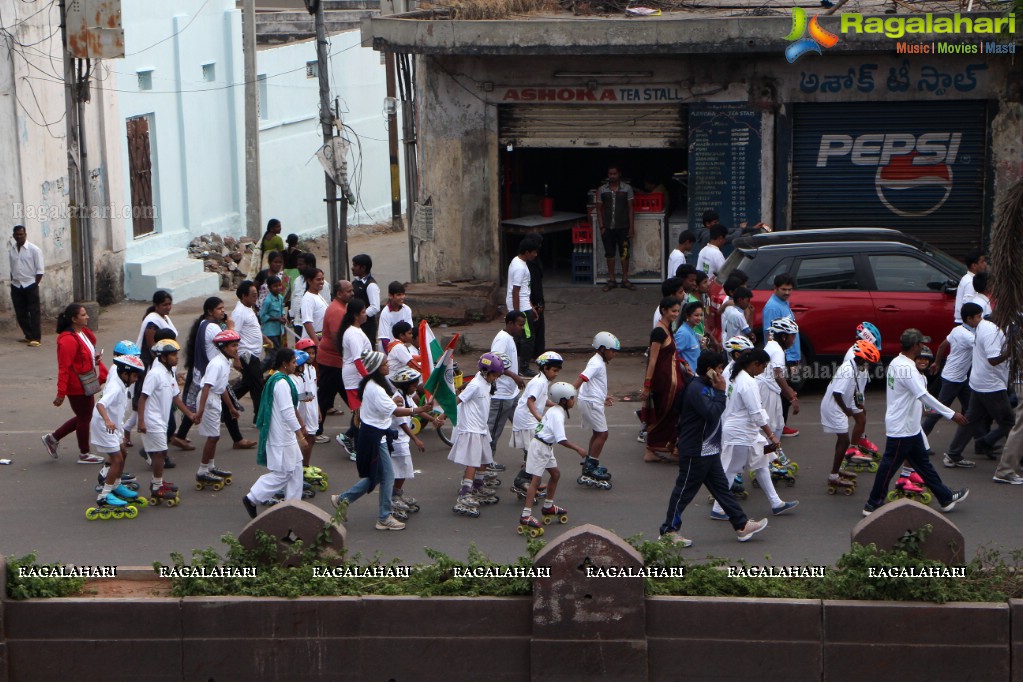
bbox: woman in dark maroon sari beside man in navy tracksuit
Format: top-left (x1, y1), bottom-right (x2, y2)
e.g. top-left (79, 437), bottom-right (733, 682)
top-left (640, 297), bottom-right (685, 462)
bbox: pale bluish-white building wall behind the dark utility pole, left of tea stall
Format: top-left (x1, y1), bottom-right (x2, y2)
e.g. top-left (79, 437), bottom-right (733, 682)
top-left (258, 31), bottom-right (404, 242)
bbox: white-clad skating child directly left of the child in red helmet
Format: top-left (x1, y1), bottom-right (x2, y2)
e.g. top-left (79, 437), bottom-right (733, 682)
top-left (138, 338), bottom-right (195, 506)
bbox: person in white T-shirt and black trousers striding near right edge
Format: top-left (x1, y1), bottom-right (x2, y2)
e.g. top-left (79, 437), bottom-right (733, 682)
top-left (944, 320), bottom-right (1023, 486)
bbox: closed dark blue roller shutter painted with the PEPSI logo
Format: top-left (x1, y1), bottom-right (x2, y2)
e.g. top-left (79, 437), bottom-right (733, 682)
top-left (792, 101), bottom-right (988, 255)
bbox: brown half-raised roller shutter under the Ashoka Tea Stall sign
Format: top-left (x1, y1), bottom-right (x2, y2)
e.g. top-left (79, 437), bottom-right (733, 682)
top-left (497, 104), bottom-right (686, 149)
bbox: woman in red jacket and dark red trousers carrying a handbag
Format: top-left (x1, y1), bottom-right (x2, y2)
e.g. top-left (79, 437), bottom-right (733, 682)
top-left (43, 303), bottom-right (107, 464)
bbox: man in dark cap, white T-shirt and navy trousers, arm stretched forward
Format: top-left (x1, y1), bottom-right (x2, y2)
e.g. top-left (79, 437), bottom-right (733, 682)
top-left (863, 329), bottom-right (970, 516)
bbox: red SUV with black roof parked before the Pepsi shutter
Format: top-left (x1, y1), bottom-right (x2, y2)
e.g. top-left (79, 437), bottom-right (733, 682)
top-left (708, 228), bottom-right (966, 364)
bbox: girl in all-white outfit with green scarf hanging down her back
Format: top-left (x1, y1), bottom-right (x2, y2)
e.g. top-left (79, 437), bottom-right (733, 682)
top-left (241, 348), bottom-right (310, 518)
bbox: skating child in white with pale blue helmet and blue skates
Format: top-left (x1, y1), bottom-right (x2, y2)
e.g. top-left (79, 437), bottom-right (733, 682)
top-left (573, 331), bottom-right (622, 490)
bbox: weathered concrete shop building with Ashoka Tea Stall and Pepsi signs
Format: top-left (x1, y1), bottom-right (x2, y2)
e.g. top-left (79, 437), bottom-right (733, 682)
top-left (363, 0), bottom-right (1023, 280)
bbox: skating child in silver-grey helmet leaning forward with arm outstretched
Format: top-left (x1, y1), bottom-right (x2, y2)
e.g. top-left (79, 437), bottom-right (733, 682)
top-left (519, 377), bottom-right (586, 538)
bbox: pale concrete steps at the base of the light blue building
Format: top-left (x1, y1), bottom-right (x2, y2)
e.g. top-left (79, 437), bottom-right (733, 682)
top-left (125, 247), bottom-right (220, 301)
